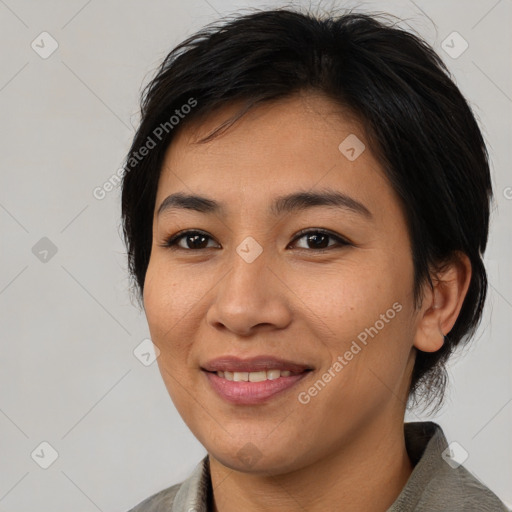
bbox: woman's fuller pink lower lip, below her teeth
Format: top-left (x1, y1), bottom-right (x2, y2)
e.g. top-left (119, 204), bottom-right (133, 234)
top-left (204, 372), bottom-right (309, 405)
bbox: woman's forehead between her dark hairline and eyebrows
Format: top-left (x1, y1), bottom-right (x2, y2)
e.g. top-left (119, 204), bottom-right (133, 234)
top-left (155, 94), bottom-right (397, 222)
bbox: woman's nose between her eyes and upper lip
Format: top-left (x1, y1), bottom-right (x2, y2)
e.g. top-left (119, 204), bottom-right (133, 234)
top-left (207, 247), bottom-right (292, 337)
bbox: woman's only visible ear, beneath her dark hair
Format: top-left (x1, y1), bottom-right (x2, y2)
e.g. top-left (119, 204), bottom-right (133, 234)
top-left (413, 252), bottom-right (471, 352)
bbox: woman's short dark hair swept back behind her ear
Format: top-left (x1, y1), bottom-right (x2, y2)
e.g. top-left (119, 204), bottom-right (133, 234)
top-left (122, 9), bottom-right (492, 404)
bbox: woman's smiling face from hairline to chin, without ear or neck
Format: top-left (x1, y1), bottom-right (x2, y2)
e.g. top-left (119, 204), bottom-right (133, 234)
top-left (144, 95), bottom-right (417, 474)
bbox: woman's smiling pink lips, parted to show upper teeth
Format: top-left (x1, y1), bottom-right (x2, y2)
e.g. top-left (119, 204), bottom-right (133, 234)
top-left (201, 356), bottom-right (312, 405)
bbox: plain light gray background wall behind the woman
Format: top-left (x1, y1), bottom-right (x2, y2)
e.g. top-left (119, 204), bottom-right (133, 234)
top-left (0, 0), bottom-right (512, 512)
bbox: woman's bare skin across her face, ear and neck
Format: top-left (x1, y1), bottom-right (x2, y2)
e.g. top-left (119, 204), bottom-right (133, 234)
top-left (144, 93), bottom-right (471, 512)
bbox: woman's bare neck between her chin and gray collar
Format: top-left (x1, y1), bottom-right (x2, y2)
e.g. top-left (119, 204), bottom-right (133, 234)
top-left (209, 422), bottom-right (413, 512)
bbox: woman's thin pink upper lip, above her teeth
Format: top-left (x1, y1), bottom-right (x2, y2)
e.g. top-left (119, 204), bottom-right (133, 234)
top-left (201, 356), bottom-right (312, 373)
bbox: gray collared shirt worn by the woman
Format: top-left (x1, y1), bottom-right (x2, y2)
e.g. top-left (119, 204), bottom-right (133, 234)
top-left (129, 422), bottom-right (508, 512)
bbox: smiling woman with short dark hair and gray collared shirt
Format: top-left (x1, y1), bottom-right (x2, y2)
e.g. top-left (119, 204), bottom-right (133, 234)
top-left (122, 10), bottom-right (506, 512)
